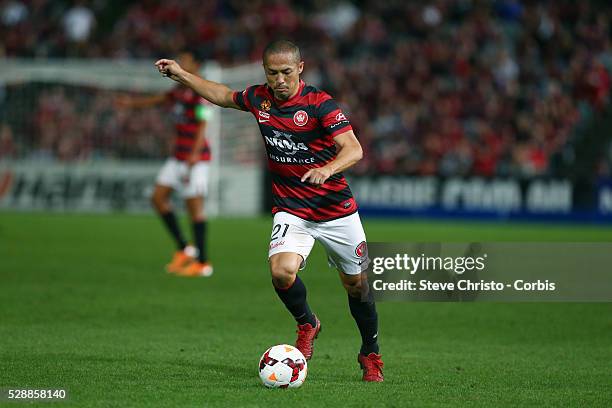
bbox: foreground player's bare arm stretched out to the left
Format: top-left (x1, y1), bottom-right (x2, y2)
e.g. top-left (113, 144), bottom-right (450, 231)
top-left (155, 59), bottom-right (240, 109)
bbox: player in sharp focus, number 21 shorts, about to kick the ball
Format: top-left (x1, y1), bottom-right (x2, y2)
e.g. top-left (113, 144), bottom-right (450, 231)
top-left (155, 40), bottom-right (383, 382)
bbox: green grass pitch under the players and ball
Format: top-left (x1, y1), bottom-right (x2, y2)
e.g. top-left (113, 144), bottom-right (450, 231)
top-left (0, 213), bottom-right (612, 407)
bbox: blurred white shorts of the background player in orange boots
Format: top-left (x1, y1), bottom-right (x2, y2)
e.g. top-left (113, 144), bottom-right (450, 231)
top-left (156, 158), bottom-right (208, 198)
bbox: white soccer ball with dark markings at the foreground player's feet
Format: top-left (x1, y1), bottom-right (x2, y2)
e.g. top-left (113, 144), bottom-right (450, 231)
top-left (259, 344), bottom-right (308, 388)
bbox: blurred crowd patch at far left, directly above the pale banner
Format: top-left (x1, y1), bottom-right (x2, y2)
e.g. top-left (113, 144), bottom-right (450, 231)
top-left (0, 84), bottom-right (173, 162)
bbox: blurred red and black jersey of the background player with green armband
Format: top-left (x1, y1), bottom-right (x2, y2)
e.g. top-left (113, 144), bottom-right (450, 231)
top-left (166, 86), bottom-right (210, 161)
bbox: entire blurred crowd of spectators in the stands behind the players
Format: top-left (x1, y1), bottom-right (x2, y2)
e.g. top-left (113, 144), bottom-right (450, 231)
top-left (0, 0), bottom-right (612, 176)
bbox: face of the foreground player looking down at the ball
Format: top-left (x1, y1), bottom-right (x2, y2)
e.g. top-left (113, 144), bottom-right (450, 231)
top-left (264, 53), bottom-right (304, 101)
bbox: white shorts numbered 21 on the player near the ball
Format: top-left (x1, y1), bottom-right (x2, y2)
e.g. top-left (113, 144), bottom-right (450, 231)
top-left (268, 212), bottom-right (370, 275)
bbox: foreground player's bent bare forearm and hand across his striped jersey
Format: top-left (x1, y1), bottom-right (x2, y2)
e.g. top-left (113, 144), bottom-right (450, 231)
top-left (302, 130), bottom-right (363, 186)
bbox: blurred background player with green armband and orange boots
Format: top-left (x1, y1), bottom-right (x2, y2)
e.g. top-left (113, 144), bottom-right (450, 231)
top-left (117, 51), bottom-right (213, 276)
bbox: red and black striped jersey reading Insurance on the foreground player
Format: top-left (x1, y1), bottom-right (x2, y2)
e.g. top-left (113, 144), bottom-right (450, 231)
top-left (233, 81), bottom-right (357, 222)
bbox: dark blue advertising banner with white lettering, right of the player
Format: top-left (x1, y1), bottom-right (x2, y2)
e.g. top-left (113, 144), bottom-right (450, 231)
top-left (350, 176), bottom-right (612, 221)
